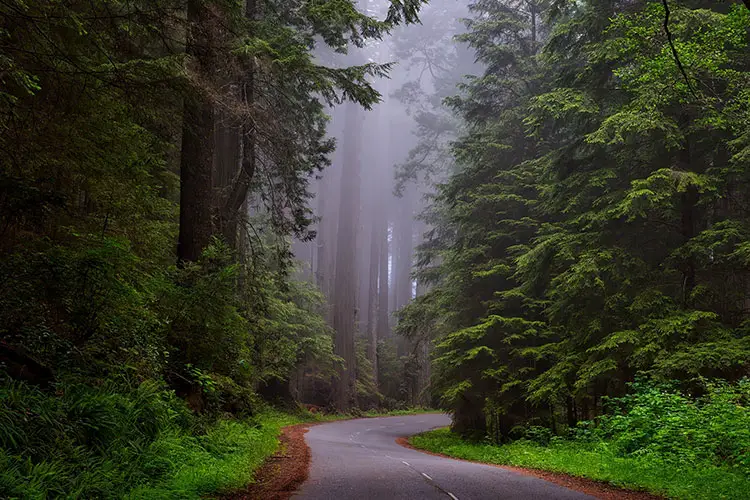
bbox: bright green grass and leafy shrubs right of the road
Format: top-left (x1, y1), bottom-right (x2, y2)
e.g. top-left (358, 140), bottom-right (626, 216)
top-left (409, 380), bottom-right (750, 500)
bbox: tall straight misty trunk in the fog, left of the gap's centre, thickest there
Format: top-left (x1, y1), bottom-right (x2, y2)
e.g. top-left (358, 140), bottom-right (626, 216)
top-left (333, 103), bottom-right (361, 411)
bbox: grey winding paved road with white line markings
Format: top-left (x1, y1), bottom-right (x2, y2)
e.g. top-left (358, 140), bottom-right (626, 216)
top-left (294, 414), bottom-right (593, 500)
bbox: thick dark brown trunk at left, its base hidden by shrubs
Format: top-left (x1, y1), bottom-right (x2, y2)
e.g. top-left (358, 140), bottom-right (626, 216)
top-left (177, 0), bottom-right (216, 262)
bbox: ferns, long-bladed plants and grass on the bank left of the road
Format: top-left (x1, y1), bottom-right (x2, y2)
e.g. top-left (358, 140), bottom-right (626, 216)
top-left (0, 380), bottom-right (302, 499)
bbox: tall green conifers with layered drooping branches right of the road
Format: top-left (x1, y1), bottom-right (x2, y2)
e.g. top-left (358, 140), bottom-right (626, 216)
top-left (402, 0), bottom-right (750, 439)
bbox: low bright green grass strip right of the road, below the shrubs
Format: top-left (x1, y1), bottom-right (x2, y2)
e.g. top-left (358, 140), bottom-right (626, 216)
top-left (409, 429), bottom-right (750, 500)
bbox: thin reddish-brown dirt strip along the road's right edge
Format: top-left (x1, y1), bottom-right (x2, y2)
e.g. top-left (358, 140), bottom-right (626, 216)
top-left (396, 437), bottom-right (663, 500)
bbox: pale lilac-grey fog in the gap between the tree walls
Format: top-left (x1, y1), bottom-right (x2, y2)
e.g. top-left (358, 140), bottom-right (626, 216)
top-left (293, 0), bottom-right (476, 406)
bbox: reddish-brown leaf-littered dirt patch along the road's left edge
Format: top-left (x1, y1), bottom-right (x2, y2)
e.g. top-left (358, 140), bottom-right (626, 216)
top-left (222, 424), bottom-right (314, 500)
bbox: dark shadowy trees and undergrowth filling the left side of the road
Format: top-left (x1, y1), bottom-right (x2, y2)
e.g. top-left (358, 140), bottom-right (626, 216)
top-left (0, 0), bottom-right (422, 498)
